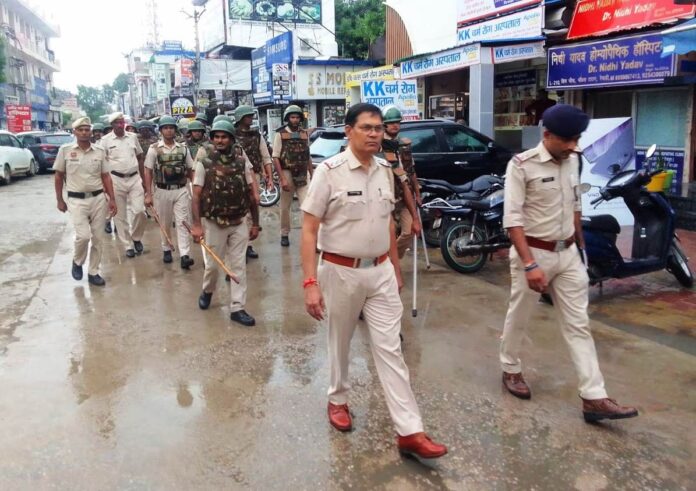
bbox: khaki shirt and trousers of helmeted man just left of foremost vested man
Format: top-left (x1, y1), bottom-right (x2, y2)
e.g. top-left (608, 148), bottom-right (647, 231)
top-left (145, 140), bottom-right (193, 256)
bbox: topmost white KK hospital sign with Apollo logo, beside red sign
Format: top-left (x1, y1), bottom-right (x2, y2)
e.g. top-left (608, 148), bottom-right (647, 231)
top-left (457, 7), bottom-right (544, 44)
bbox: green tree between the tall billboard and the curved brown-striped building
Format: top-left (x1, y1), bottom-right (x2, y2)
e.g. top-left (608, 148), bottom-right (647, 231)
top-left (336, 0), bottom-right (386, 60)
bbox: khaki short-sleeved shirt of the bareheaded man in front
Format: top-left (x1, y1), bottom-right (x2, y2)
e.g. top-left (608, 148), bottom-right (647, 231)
top-left (302, 148), bottom-right (394, 258)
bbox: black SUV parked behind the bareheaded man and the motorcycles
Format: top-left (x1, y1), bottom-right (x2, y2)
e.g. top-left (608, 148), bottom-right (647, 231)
top-left (310, 119), bottom-right (512, 184)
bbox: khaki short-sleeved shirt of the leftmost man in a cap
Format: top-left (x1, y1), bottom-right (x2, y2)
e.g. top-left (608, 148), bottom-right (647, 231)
top-left (53, 142), bottom-right (109, 193)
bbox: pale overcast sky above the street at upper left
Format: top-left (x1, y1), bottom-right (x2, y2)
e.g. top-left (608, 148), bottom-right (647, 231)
top-left (25, 0), bottom-right (194, 93)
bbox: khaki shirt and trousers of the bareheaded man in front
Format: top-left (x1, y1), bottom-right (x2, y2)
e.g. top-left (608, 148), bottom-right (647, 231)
top-left (302, 149), bottom-right (423, 436)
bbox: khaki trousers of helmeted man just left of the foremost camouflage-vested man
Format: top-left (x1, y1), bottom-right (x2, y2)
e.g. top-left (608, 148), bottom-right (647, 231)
top-left (153, 186), bottom-right (191, 256)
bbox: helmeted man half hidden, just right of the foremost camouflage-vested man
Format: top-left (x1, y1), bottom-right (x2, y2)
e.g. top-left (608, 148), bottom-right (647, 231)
top-left (234, 106), bottom-right (273, 259)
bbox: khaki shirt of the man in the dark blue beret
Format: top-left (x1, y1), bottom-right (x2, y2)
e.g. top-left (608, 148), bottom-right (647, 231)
top-left (503, 142), bottom-right (582, 240)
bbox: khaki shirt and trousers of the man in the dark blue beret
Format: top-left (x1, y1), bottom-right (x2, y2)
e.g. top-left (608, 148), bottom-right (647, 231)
top-left (500, 142), bottom-right (607, 399)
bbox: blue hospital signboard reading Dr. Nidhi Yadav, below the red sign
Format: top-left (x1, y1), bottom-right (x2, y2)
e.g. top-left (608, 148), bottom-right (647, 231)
top-left (546, 34), bottom-right (676, 89)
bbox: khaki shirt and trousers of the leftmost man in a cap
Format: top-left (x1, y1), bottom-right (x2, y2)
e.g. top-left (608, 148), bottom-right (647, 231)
top-left (53, 142), bottom-right (109, 276)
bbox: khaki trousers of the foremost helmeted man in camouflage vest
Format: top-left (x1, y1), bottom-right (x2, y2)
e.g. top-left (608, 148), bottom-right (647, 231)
top-left (201, 218), bottom-right (249, 312)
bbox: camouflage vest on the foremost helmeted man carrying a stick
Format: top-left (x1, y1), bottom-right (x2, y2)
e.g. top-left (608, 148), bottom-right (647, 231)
top-left (201, 143), bottom-right (249, 227)
